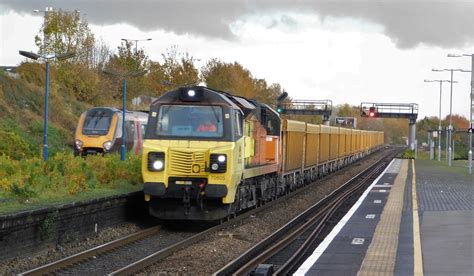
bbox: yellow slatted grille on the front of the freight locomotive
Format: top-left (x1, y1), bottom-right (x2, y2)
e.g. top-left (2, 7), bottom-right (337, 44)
top-left (170, 150), bottom-right (206, 175)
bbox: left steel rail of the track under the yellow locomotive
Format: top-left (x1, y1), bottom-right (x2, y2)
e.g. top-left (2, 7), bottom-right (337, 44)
top-left (19, 225), bottom-right (161, 275)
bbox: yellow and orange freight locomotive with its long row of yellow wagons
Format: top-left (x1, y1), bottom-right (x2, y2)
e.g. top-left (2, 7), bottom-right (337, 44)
top-left (142, 86), bottom-right (383, 220)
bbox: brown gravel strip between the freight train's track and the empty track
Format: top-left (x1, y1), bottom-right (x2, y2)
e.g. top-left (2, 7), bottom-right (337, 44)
top-left (142, 147), bottom-right (387, 275)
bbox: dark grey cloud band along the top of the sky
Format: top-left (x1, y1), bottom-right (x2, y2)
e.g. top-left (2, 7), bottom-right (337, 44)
top-left (0, 0), bottom-right (474, 48)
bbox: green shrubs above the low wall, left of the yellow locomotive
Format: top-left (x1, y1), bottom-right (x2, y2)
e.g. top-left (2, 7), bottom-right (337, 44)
top-left (0, 152), bottom-right (141, 209)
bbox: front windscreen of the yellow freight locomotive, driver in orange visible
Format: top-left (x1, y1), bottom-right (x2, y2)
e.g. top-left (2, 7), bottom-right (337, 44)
top-left (155, 105), bottom-right (224, 138)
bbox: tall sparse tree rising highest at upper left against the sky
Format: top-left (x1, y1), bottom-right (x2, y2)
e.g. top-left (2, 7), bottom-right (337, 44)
top-left (35, 10), bottom-right (95, 67)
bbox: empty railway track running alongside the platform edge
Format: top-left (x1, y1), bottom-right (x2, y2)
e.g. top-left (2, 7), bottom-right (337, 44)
top-left (215, 150), bottom-right (394, 275)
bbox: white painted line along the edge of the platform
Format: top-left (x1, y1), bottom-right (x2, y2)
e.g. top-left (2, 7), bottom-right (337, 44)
top-left (293, 159), bottom-right (395, 275)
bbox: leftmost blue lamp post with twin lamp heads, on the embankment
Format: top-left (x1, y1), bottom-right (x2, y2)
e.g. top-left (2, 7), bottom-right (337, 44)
top-left (19, 51), bottom-right (75, 161)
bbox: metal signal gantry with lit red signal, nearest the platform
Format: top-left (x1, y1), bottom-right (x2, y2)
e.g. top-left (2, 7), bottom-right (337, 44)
top-left (360, 102), bottom-right (418, 150)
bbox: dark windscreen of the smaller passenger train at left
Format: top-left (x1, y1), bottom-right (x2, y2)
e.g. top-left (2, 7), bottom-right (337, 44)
top-left (82, 108), bottom-right (114, 135)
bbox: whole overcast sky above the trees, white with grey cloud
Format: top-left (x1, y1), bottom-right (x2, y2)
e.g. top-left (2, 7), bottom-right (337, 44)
top-left (0, 0), bottom-right (474, 118)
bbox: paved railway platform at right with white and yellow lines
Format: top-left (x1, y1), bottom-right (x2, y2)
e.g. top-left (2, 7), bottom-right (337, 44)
top-left (294, 159), bottom-right (474, 275)
